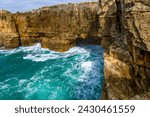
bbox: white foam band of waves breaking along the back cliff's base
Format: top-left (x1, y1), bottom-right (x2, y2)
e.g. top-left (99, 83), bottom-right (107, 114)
top-left (0, 43), bottom-right (90, 62)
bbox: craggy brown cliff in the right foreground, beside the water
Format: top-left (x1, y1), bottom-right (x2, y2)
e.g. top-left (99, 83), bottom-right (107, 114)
top-left (99, 0), bottom-right (150, 99)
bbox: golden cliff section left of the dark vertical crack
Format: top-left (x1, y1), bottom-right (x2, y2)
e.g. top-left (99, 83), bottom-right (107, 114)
top-left (0, 10), bottom-right (19, 48)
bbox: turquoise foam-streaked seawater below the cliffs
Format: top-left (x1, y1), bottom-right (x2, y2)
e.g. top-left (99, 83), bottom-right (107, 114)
top-left (0, 44), bottom-right (104, 100)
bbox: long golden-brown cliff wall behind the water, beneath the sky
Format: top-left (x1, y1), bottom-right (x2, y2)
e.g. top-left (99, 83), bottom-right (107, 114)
top-left (0, 2), bottom-right (99, 51)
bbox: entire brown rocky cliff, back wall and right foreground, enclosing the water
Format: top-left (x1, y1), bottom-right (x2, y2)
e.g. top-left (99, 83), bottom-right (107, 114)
top-left (0, 0), bottom-right (150, 99)
